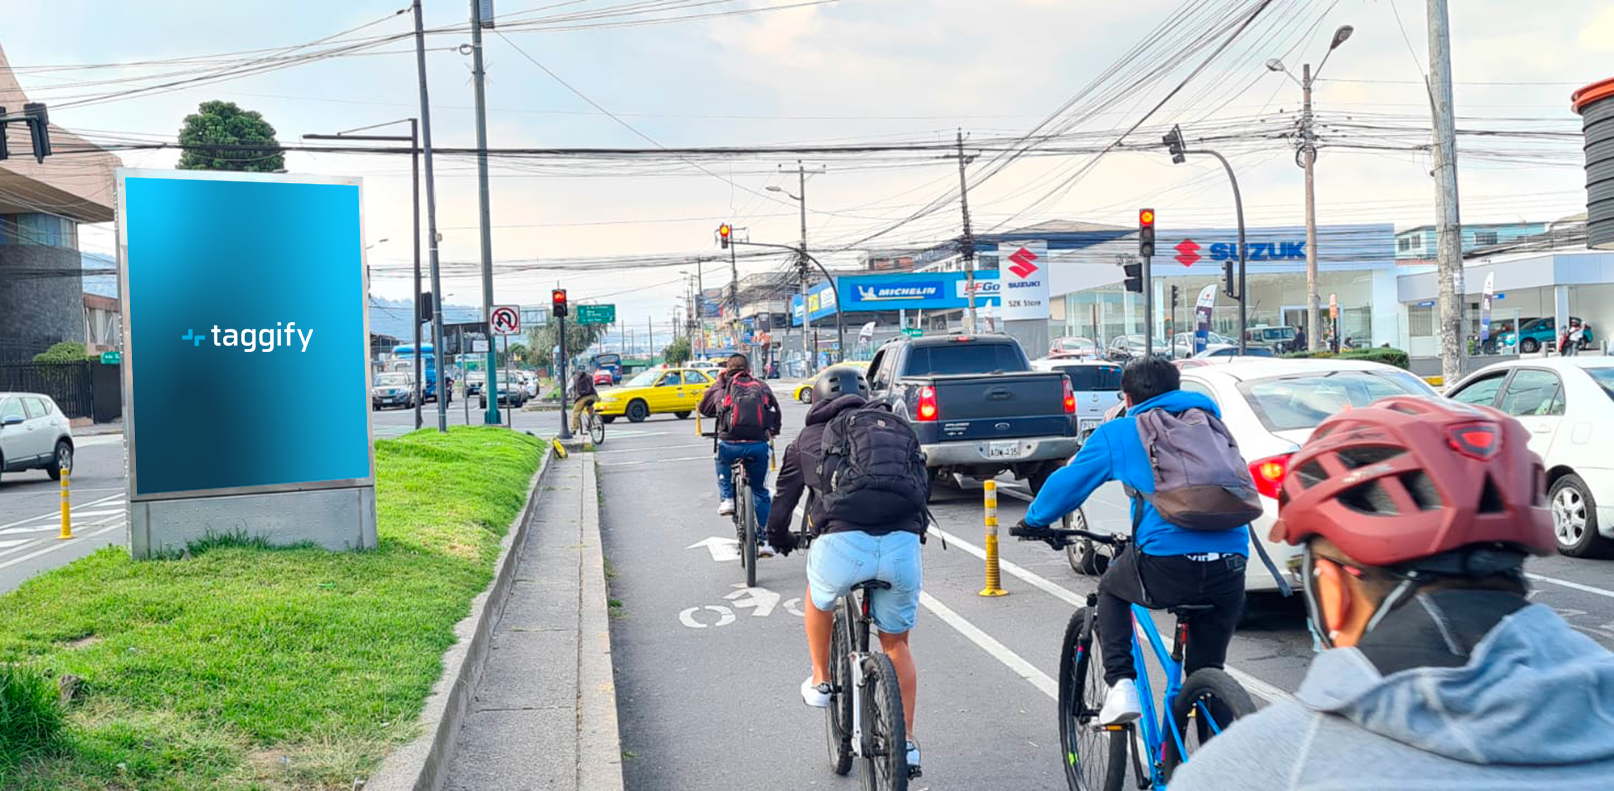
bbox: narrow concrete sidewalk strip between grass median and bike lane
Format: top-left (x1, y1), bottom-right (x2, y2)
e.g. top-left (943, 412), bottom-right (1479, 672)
top-left (442, 452), bottom-right (623, 791)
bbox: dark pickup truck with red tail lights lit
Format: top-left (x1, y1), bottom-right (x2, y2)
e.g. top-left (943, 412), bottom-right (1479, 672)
top-left (868, 334), bottom-right (1080, 494)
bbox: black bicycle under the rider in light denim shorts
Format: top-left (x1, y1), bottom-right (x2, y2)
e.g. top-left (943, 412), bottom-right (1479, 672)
top-left (823, 580), bottom-right (918, 791)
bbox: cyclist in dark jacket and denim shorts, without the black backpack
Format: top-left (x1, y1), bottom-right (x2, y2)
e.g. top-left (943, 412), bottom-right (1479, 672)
top-left (768, 366), bottom-right (925, 770)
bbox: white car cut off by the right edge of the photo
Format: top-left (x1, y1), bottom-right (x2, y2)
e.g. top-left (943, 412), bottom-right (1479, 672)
top-left (1446, 357), bottom-right (1614, 557)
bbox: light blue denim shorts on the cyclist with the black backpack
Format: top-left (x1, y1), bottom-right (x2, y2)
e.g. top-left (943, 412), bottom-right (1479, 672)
top-left (807, 531), bottom-right (925, 634)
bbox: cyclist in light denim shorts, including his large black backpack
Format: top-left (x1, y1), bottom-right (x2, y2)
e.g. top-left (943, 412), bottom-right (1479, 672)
top-left (768, 365), bottom-right (930, 776)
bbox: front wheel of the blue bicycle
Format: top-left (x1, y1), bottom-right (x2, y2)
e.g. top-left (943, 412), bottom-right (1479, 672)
top-left (1059, 607), bottom-right (1127, 791)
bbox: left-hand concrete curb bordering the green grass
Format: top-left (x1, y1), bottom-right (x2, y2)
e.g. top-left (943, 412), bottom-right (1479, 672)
top-left (363, 446), bottom-right (561, 791)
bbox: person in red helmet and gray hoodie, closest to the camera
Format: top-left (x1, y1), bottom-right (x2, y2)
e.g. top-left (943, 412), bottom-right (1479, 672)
top-left (1172, 397), bottom-right (1614, 791)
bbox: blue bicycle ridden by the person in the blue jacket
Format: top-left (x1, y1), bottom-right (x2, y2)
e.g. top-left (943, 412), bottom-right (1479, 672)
top-left (1009, 521), bottom-right (1256, 791)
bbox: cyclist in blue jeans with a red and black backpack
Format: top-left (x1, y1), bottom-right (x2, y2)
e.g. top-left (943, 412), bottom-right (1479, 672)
top-left (699, 354), bottom-right (781, 557)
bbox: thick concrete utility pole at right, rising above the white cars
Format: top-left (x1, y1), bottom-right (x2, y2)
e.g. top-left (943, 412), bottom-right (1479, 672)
top-left (1428, 0), bottom-right (1467, 383)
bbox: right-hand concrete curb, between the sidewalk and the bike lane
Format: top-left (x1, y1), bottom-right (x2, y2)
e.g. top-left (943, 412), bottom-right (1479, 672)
top-left (578, 454), bottom-right (623, 791)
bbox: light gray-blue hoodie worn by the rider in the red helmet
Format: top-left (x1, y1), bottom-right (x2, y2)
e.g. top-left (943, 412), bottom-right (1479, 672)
top-left (1172, 597), bottom-right (1614, 791)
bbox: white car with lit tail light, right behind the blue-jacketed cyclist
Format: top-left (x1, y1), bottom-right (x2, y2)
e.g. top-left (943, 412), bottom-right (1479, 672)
top-left (1070, 358), bottom-right (1438, 591)
